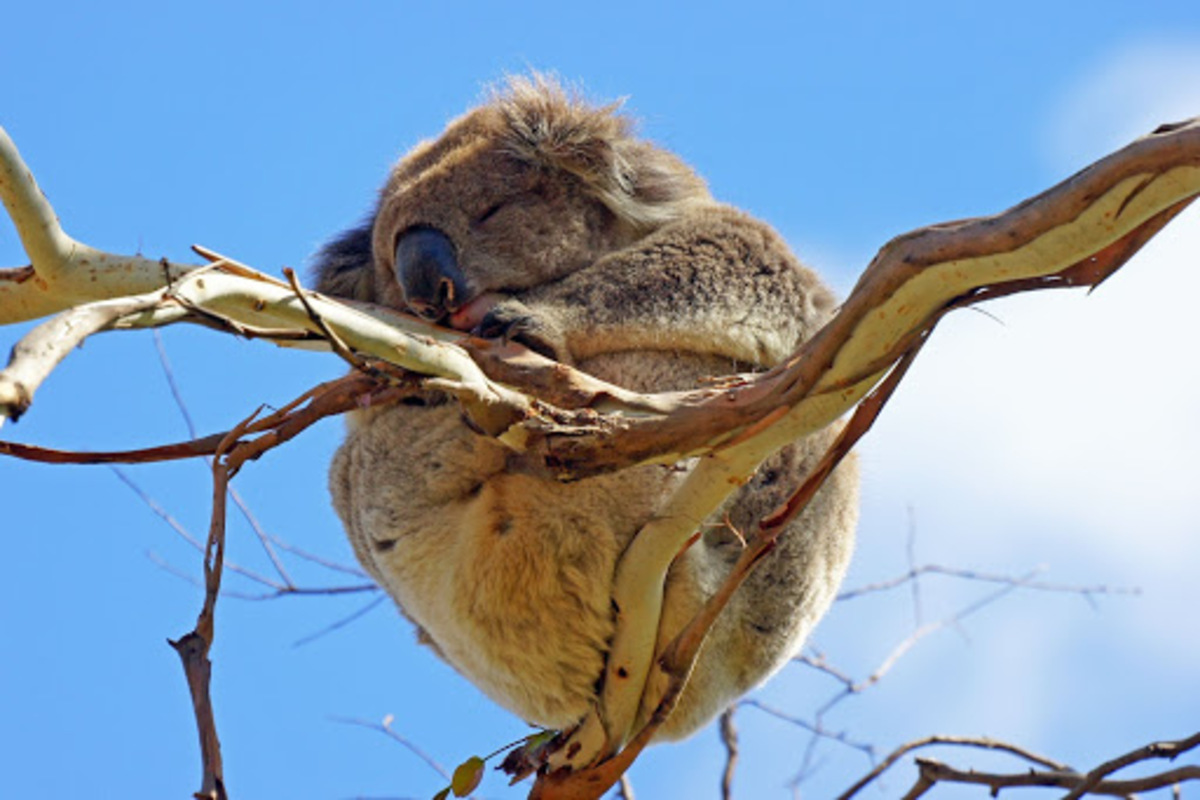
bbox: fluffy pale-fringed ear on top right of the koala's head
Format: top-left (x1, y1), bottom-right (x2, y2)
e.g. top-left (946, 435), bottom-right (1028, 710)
top-left (492, 73), bottom-right (713, 228)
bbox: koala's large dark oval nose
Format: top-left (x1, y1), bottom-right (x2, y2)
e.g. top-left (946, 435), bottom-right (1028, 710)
top-left (396, 225), bottom-right (470, 320)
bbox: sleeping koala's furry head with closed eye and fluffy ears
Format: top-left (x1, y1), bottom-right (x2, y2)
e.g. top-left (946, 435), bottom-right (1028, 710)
top-left (317, 74), bottom-right (713, 320)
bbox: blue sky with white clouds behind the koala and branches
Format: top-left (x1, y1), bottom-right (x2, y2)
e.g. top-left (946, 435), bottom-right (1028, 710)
top-left (0, 1), bottom-right (1200, 798)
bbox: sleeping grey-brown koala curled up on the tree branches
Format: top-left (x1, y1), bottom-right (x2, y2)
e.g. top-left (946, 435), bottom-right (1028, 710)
top-left (314, 74), bottom-right (858, 740)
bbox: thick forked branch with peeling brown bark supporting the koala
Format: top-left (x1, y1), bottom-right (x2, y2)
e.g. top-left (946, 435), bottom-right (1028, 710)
top-left (0, 113), bottom-right (1200, 798)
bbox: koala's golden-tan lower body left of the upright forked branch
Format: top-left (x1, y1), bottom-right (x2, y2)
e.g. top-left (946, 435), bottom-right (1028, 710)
top-left (330, 403), bottom-right (679, 727)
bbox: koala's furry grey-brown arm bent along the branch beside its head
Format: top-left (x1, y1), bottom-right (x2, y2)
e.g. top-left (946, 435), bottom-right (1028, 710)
top-left (511, 204), bottom-right (834, 366)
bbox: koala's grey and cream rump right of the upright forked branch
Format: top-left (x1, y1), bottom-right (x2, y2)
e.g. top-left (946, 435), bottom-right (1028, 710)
top-left (658, 431), bottom-right (858, 740)
